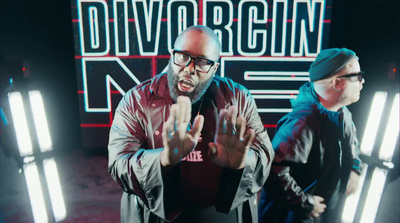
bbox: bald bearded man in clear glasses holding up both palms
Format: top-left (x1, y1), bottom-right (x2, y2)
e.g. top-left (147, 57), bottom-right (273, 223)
top-left (108, 26), bottom-right (274, 223)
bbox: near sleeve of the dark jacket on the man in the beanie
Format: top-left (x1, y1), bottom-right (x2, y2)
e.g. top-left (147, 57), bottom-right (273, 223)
top-left (268, 116), bottom-right (314, 214)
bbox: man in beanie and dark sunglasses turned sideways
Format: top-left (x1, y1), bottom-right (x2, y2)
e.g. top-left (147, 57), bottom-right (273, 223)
top-left (259, 48), bottom-right (364, 223)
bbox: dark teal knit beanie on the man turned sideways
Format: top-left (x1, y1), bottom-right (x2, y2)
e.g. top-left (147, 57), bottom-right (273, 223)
top-left (308, 48), bottom-right (357, 82)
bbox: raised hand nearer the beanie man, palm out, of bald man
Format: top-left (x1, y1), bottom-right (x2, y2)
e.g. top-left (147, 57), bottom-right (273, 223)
top-left (208, 107), bottom-right (255, 170)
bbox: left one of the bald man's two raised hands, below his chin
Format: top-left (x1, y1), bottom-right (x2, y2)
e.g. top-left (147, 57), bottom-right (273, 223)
top-left (160, 96), bottom-right (204, 167)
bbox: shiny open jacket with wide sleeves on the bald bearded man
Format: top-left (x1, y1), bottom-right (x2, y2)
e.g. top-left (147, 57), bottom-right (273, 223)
top-left (108, 74), bottom-right (274, 222)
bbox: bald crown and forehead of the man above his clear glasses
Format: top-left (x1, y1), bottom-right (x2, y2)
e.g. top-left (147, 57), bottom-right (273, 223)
top-left (174, 25), bottom-right (221, 60)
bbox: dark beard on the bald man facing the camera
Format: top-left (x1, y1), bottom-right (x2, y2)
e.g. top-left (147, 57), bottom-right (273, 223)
top-left (167, 64), bottom-right (213, 104)
